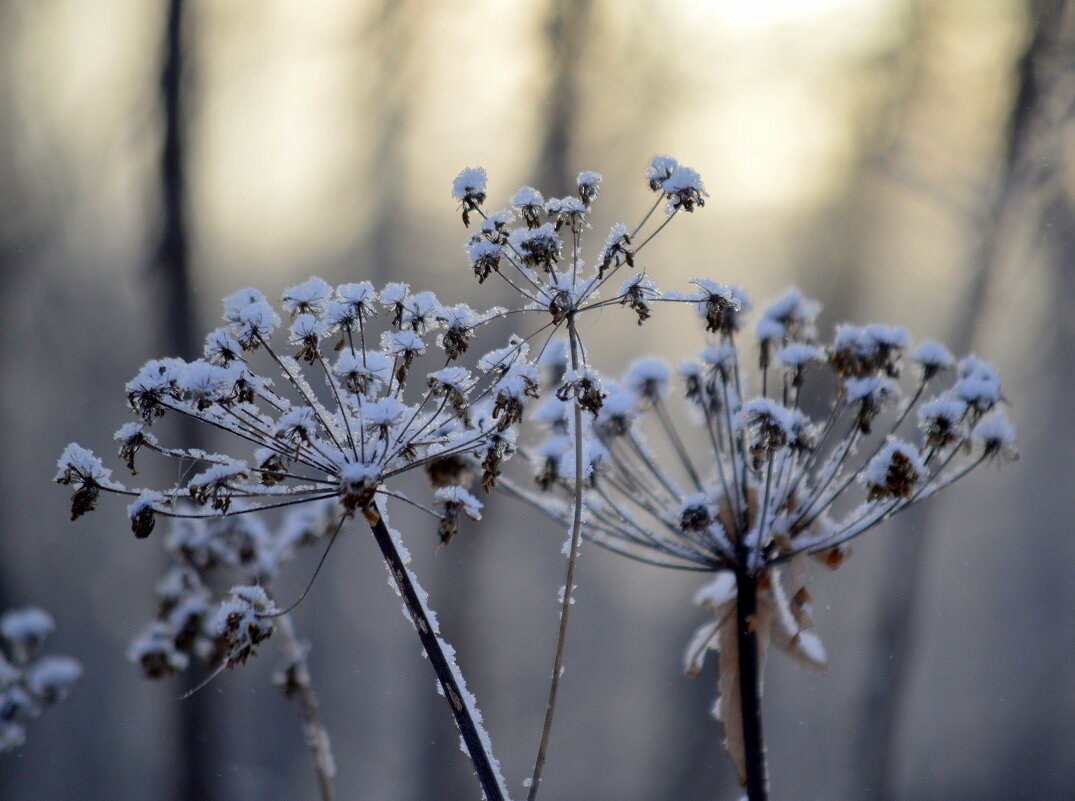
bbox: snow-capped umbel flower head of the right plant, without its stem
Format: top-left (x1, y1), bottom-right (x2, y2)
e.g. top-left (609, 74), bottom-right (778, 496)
top-left (520, 280), bottom-right (1015, 573)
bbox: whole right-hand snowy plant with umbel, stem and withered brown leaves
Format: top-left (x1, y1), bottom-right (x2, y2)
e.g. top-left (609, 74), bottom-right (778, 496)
top-left (511, 280), bottom-right (1015, 801)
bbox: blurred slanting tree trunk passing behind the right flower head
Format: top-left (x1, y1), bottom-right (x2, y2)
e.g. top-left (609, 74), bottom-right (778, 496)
top-left (855, 0), bottom-right (1075, 801)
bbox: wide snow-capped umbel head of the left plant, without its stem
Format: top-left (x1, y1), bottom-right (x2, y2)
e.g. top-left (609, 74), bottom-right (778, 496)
top-left (56, 277), bottom-right (533, 537)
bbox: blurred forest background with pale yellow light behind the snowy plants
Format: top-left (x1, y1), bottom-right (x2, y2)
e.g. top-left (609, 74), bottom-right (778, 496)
top-left (0, 0), bottom-right (1075, 801)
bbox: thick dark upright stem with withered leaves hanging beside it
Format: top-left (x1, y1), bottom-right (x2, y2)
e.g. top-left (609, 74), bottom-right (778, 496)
top-left (735, 567), bottom-right (769, 801)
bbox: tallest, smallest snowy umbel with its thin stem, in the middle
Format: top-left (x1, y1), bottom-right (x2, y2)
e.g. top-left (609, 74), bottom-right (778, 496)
top-left (452, 156), bottom-right (708, 801)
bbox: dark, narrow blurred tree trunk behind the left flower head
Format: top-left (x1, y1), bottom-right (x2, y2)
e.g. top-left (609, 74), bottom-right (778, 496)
top-left (149, 0), bottom-right (219, 801)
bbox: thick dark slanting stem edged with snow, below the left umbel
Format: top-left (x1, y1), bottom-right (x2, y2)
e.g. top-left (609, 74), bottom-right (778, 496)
top-left (370, 514), bottom-right (505, 801)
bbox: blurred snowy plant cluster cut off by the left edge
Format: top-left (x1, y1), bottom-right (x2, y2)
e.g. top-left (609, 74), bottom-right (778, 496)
top-left (0, 606), bottom-right (82, 754)
